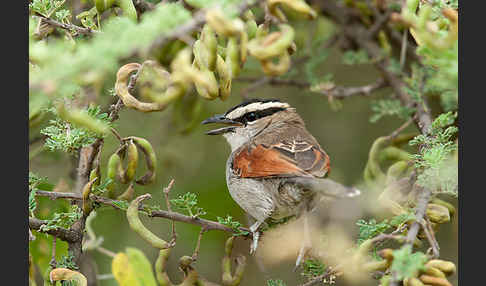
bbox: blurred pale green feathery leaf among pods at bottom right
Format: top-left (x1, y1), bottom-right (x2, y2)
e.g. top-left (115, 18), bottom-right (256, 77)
top-left (390, 244), bottom-right (427, 280)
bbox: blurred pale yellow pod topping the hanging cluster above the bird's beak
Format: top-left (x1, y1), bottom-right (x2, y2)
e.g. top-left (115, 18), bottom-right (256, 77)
top-left (206, 8), bottom-right (245, 37)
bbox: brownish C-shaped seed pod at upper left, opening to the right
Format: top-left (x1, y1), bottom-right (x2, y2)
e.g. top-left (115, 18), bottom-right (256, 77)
top-left (115, 63), bottom-right (174, 112)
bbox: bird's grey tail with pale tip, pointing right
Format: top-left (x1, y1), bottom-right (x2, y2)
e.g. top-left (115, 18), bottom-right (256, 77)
top-left (288, 177), bottom-right (361, 198)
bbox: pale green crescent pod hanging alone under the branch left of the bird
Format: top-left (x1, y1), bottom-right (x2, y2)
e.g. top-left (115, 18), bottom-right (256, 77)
top-left (127, 194), bottom-right (169, 249)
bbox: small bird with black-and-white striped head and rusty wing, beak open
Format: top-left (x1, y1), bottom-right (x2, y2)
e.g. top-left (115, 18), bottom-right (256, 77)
top-left (202, 98), bottom-right (360, 267)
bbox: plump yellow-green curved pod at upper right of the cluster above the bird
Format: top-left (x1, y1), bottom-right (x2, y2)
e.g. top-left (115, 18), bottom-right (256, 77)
top-left (248, 24), bottom-right (295, 60)
